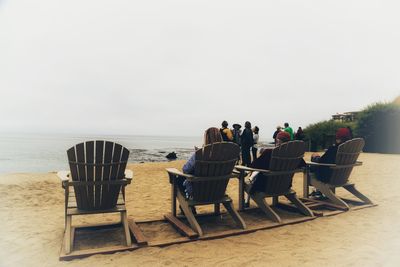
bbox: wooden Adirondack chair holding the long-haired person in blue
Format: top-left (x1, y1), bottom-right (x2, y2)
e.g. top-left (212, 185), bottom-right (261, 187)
top-left (166, 142), bottom-right (246, 236)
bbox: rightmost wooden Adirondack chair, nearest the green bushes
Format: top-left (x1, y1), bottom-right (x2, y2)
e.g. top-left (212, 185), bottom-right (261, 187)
top-left (307, 138), bottom-right (372, 210)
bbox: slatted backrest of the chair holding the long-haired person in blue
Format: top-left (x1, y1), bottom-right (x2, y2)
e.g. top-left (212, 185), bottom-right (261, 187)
top-left (192, 142), bottom-right (240, 202)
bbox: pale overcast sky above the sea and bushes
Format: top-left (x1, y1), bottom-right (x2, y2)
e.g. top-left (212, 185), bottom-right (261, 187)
top-left (0, 0), bottom-right (400, 138)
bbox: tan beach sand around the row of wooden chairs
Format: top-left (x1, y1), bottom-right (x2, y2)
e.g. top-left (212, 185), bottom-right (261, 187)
top-left (0, 153), bottom-right (400, 266)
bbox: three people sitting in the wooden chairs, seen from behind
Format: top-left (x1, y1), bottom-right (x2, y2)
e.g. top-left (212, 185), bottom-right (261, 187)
top-left (178, 127), bottom-right (352, 202)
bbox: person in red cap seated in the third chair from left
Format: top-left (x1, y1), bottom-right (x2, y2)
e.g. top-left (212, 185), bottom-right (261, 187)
top-left (244, 131), bottom-right (306, 200)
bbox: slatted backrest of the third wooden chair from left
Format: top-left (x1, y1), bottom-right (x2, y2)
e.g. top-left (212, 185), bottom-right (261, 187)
top-left (264, 141), bottom-right (306, 195)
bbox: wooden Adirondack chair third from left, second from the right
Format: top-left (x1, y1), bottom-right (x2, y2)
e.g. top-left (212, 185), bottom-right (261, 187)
top-left (235, 141), bottom-right (314, 223)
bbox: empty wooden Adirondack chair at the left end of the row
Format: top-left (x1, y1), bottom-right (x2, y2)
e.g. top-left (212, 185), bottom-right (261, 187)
top-left (58, 141), bottom-right (136, 254)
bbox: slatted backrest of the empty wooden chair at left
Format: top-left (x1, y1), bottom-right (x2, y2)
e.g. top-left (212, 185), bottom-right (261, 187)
top-left (67, 141), bottom-right (129, 210)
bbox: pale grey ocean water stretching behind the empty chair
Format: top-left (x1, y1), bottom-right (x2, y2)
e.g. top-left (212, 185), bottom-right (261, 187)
top-left (0, 134), bottom-right (272, 174)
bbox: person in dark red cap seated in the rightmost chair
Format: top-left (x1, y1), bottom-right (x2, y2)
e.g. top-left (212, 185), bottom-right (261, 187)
top-left (311, 128), bottom-right (352, 182)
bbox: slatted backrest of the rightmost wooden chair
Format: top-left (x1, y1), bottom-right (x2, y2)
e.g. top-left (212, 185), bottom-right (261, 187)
top-left (329, 138), bottom-right (365, 185)
